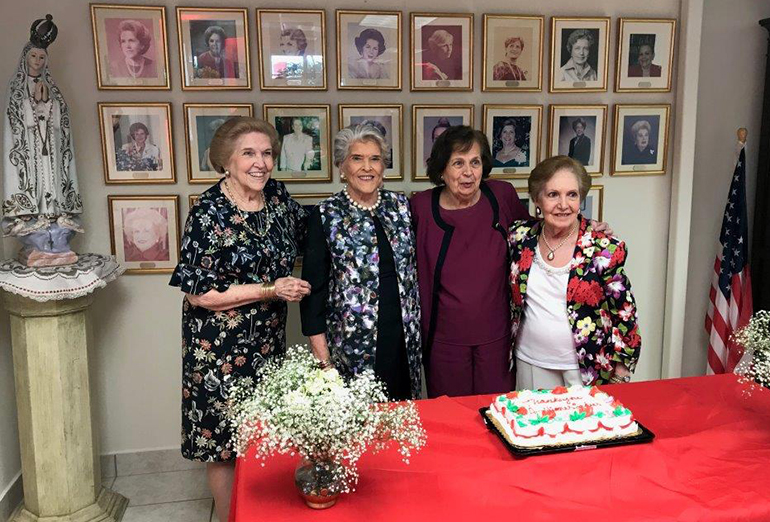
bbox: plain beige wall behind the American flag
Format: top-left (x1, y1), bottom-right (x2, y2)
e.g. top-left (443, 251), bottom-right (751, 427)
top-left (682, 0), bottom-right (770, 375)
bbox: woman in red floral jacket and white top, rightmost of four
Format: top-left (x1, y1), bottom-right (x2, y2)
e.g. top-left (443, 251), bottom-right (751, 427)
top-left (509, 156), bottom-right (641, 389)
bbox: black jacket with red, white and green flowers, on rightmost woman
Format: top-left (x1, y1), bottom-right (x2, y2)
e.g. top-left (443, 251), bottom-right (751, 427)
top-left (508, 216), bottom-right (642, 385)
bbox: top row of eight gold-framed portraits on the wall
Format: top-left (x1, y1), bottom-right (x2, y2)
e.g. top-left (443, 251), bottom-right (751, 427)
top-left (91, 4), bottom-right (676, 92)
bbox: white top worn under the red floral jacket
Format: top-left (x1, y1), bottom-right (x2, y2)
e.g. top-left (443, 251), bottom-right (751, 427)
top-left (516, 247), bottom-right (579, 370)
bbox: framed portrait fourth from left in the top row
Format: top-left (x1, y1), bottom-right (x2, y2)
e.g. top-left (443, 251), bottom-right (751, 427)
top-left (337, 9), bottom-right (401, 90)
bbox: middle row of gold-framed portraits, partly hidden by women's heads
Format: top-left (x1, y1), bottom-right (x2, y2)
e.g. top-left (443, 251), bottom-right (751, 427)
top-left (98, 103), bottom-right (671, 184)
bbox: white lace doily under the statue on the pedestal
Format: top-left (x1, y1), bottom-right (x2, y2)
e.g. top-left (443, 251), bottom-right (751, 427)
top-left (0, 254), bottom-right (126, 302)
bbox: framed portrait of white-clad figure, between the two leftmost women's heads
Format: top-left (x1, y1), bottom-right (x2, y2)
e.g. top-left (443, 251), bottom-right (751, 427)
top-left (262, 104), bottom-right (331, 183)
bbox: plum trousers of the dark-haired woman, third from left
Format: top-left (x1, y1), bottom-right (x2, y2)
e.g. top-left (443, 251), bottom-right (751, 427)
top-left (425, 335), bottom-right (513, 398)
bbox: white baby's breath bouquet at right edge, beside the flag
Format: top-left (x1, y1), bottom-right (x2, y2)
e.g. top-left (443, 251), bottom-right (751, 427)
top-left (733, 310), bottom-right (770, 388)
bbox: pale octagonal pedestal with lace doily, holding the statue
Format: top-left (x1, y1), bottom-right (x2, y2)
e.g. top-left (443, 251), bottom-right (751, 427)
top-left (0, 254), bottom-right (128, 522)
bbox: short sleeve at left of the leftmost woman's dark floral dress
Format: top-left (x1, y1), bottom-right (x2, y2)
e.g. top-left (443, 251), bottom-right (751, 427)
top-left (168, 200), bottom-right (225, 295)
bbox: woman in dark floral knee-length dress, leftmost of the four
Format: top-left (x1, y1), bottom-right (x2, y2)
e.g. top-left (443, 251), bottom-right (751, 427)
top-left (169, 117), bottom-right (310, 520)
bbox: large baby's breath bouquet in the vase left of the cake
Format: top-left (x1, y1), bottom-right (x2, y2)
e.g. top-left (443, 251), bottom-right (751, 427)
top-left (228, 346), bottom-right (426, 493)
